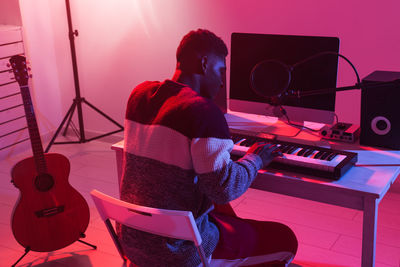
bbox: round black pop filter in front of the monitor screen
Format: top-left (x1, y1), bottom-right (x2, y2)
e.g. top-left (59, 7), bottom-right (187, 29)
top-left (250, 60), bottom-right (292, 104)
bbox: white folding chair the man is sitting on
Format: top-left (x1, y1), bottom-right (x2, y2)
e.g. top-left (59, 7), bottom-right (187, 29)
top-left (90, 190), bottom-right (210, 267)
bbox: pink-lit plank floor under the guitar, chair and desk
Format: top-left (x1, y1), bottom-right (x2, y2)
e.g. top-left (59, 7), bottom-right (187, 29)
top-left (0, 141), bottom-right (400, 267)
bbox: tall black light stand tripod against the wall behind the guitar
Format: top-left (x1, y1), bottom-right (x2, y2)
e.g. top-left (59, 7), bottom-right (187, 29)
top-left (45, 0), bottom-right (124, 153)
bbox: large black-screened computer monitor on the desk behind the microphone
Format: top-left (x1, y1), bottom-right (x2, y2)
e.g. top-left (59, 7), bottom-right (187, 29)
top-left (228, 33), bottom-right (339, 124)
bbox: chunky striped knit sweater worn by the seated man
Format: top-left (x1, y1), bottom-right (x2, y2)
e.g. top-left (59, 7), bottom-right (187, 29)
top-left (117, 80), bottom-right (262, 267)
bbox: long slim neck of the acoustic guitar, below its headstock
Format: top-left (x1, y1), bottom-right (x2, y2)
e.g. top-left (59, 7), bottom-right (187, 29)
top-left (20, 85), bottom-right (47, 173)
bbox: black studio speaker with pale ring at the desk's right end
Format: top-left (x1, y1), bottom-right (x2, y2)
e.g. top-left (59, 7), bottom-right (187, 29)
top-left (360, 71), bottom-right (400, 149)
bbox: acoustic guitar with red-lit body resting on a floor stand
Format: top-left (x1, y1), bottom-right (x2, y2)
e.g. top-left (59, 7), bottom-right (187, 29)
top-left (10, 55), bottom-right (89, 252)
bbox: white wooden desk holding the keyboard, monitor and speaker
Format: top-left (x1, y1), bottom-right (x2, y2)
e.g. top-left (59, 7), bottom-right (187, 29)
top-left (112, 112), bottom-right (400, 267)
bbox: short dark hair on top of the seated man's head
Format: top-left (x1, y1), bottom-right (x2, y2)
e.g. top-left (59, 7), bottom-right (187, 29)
top-left (176, 29), bottom-right (228, 63)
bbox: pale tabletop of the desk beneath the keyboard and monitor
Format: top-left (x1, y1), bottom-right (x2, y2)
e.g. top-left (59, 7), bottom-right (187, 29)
top-left (226, 112), bottom-right (400, 202)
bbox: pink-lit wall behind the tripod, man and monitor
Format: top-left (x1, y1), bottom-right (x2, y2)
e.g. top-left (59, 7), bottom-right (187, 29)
top-left (20, 0), bottom-right (400, 137)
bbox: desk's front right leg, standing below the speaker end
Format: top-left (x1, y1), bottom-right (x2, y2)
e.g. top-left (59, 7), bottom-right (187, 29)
top-left (361, 197), bottom-right (378, 267)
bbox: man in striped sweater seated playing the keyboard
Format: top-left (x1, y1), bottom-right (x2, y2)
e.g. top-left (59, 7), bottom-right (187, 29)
top-left (118, 29), bottom-right (297, 267)
